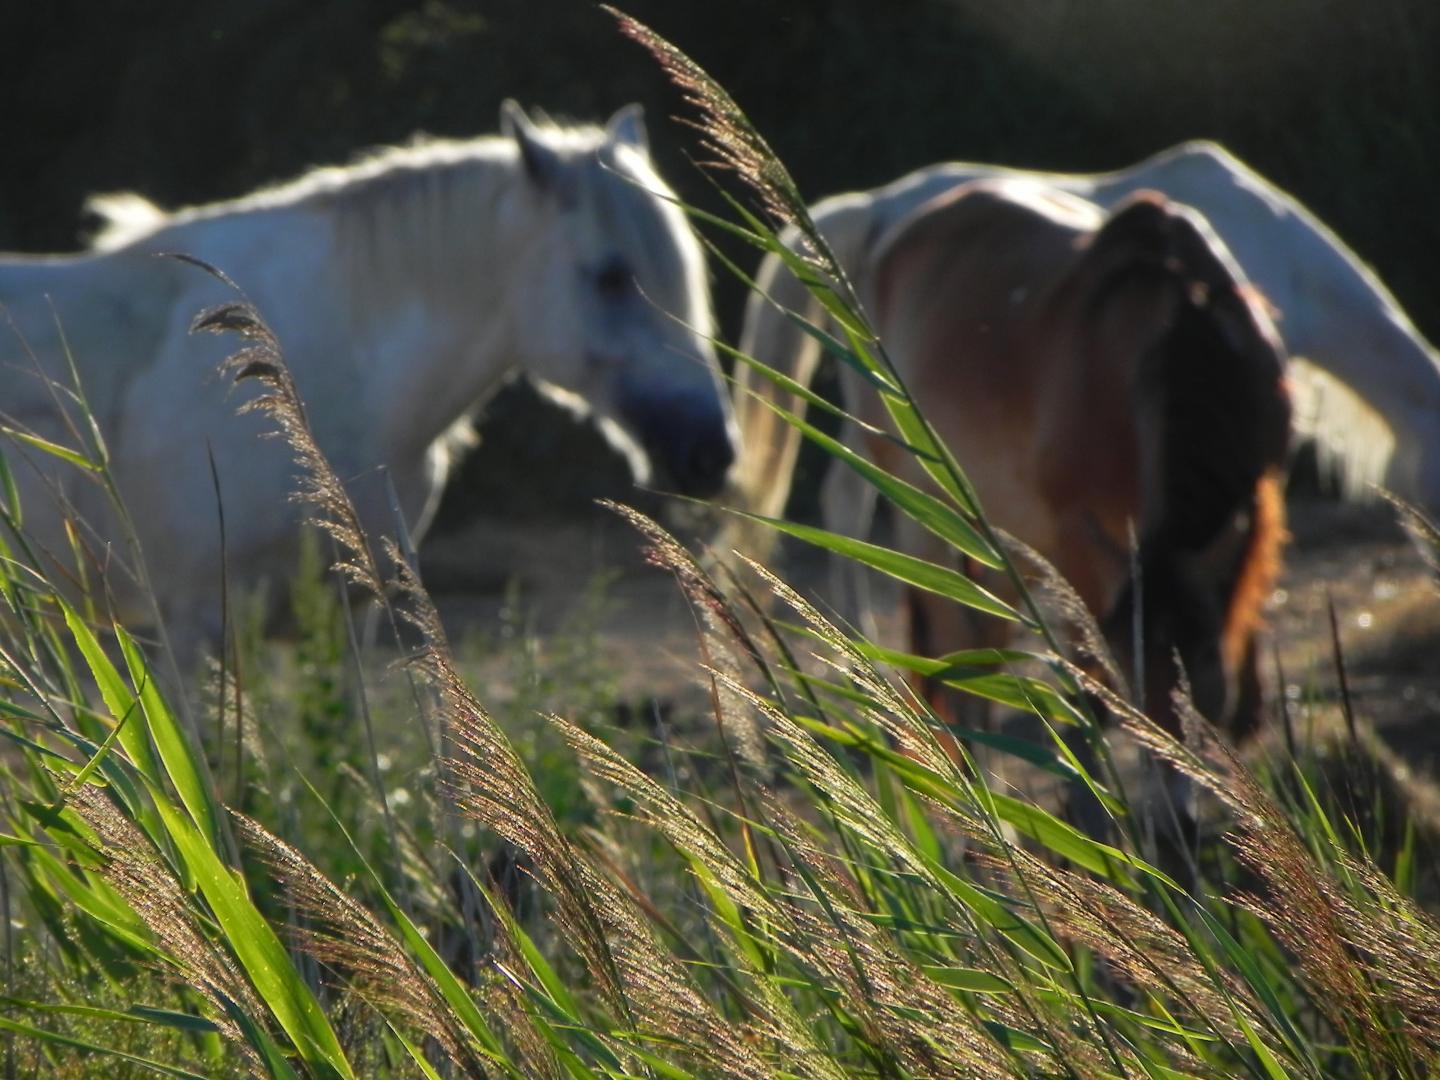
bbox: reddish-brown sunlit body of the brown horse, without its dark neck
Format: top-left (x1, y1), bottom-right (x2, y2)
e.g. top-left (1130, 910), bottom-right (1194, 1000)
top-left (870, 180), bottom-right (1136, 578)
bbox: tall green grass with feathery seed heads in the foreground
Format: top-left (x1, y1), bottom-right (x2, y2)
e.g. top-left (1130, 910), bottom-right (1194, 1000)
top-left (0, 22), bottom-right (1440, 1079)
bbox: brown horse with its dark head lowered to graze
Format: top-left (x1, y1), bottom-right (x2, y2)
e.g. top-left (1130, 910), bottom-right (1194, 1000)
top-left (742, 180), bottom-right (1290, 736)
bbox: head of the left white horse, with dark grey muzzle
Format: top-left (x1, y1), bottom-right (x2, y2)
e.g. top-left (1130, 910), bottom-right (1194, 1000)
top-left (501, 102), bottom-right (737, 497)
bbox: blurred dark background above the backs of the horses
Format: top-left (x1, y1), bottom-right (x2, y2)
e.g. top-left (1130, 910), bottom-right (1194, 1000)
top-left (0, 0), bottom-right (1440, 584)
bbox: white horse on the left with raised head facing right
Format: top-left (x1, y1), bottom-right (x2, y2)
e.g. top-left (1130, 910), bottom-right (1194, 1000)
top-left (0, 102), bottom-right (734, 639)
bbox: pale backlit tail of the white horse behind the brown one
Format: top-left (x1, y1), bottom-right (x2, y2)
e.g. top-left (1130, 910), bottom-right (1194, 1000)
top-left (734, 194), bottom-right (873, 550)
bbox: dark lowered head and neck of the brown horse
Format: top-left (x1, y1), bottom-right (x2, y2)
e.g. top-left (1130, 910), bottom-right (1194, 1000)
top-left (1080, 192), bottom-right (1290, 727)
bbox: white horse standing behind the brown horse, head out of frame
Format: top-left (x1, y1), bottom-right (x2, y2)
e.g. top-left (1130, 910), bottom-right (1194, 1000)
top-left (736, 141), bottom-right (1440, 526)
